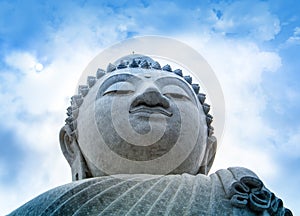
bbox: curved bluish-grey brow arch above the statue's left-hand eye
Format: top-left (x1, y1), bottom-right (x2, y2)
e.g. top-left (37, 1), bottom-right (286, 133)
top-left (96, 73), bottom-right (141, 98)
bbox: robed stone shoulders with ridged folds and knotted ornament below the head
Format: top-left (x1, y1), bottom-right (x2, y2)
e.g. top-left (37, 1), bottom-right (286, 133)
top-left (10, 171), bottom-right (291, 216)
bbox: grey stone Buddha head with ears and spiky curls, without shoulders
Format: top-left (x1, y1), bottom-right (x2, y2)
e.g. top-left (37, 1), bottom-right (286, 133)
top-left (60, 54), bottom-right (217, 180)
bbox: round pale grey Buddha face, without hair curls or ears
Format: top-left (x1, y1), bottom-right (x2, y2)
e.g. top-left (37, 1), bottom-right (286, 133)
top-left (77, 68), bottom-right (207, 176)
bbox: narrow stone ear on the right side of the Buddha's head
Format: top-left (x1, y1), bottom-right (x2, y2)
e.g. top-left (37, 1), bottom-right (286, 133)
top-left (198, 136), bottom-right (217, 175)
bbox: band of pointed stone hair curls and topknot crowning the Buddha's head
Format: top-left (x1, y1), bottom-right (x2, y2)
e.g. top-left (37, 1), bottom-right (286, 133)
top-left (65, 54), bottom-right (214, 138)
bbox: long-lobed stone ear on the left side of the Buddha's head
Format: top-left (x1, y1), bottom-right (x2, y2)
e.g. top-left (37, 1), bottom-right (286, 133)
top-left (59, 125), bottom-right (92, 181)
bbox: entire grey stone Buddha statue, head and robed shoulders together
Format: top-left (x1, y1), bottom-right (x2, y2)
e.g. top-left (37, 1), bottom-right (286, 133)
top-left (10, 54), bottom-right (292, 216)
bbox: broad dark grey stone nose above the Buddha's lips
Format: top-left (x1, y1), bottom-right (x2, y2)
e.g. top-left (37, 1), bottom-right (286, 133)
top-left (132, 87), bottom-right (170, 109)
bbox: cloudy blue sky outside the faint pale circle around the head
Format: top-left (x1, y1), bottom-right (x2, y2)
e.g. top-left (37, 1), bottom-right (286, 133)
top-left (0, 0), bottom-right (300, 215)
